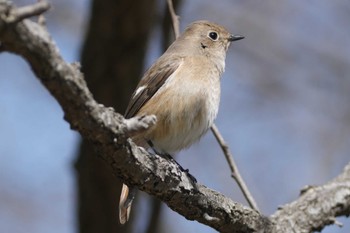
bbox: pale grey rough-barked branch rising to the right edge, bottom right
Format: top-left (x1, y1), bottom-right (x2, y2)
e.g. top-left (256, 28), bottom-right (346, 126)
top-left (271, 164), bottom-right (350, 232)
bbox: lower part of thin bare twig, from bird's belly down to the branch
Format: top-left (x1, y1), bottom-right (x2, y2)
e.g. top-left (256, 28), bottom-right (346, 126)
top-left (211, 124), bottom-right (259, 211)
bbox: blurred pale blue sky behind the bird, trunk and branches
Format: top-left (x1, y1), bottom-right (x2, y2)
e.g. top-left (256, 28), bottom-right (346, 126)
top-left (0, 0), bottom-right (350, 233)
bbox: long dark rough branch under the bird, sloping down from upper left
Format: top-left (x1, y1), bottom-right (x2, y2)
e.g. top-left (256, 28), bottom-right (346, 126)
top-left (0, 0), bottom-right (269, 232)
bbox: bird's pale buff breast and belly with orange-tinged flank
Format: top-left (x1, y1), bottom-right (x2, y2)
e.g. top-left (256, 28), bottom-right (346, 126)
top-left (140, 59), bottom-right (220, 154)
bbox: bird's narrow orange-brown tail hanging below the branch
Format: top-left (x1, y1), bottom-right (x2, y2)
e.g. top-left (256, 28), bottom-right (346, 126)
top-left (119, 184), bottom-right (136, 224)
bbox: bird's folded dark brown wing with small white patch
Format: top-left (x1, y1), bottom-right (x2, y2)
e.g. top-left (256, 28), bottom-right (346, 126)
top-left (124, 57), bottom-right (182, 118)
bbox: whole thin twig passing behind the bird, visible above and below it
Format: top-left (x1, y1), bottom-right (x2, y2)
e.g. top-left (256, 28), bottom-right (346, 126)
top-left (167, 0), bottom-right (259, 211)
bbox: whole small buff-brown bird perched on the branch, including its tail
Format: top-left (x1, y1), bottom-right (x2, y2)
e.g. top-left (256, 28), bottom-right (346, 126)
top-left (119, 20), bottom-right (244, 224)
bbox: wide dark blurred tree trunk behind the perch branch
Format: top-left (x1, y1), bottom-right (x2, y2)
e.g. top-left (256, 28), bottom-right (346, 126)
top-left (76, 0), bottom-right (156, 233)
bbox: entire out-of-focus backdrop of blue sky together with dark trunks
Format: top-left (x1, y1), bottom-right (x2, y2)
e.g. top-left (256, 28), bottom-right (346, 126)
top-left (0, 0), bottom-right (350, 233)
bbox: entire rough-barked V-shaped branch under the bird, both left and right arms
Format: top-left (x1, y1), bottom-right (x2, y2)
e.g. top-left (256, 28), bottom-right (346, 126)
top-left (0, 0), bottom-right (350, 232)
